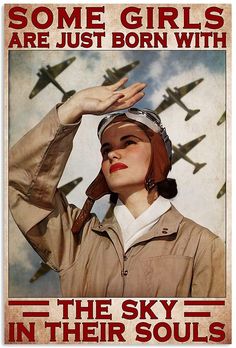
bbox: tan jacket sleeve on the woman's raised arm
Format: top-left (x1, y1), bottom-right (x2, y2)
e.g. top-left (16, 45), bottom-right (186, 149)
top-left (9, 107), bottom-right (83, 271)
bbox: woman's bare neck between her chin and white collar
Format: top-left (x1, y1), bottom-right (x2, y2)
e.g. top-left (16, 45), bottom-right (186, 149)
top-left (119, 188), bottom-right (158, 219)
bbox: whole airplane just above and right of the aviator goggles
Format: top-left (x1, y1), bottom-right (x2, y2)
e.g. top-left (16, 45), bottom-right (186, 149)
top-left (155, 78), bottom-right (203, 121)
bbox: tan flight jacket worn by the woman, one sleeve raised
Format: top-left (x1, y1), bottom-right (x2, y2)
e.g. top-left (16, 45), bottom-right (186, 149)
top-left (9, 107), bottom-right (225, 297)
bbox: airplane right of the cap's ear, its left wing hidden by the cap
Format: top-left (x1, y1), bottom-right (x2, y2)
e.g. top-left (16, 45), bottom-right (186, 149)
top-left (171, 135), bottom-right (206, 174)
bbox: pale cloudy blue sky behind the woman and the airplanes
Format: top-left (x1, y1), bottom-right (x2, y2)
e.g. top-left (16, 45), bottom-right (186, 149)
top-left (8, 50), bottom-right (227, 297)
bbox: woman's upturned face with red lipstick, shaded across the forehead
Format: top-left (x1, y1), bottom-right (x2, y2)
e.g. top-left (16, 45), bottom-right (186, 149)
top-left (101, 122), bottom-right (151, 194)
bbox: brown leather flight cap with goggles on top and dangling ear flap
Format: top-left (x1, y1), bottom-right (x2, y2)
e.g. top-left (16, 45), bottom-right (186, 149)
top-left (72, 108), bottom-right (172, 233)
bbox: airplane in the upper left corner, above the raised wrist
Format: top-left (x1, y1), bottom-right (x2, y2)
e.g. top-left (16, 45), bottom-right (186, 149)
top-left (29, 57), bottom-right (76, 102)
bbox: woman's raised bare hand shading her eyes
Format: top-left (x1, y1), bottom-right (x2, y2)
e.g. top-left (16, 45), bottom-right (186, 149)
top-left (58, 77), bottom-right (146, 124)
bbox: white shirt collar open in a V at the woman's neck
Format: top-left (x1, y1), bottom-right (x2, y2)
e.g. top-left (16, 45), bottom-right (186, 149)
top-left (114, 196), bottom-right (171, 252)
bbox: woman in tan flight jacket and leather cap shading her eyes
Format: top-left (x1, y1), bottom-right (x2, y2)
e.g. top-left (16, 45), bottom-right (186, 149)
top-left (9, 79), bottom-right (225, 297)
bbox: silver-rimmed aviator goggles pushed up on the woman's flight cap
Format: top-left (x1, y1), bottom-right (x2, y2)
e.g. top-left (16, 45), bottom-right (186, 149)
top-left (97, 108), bottom-right (172, 161)
